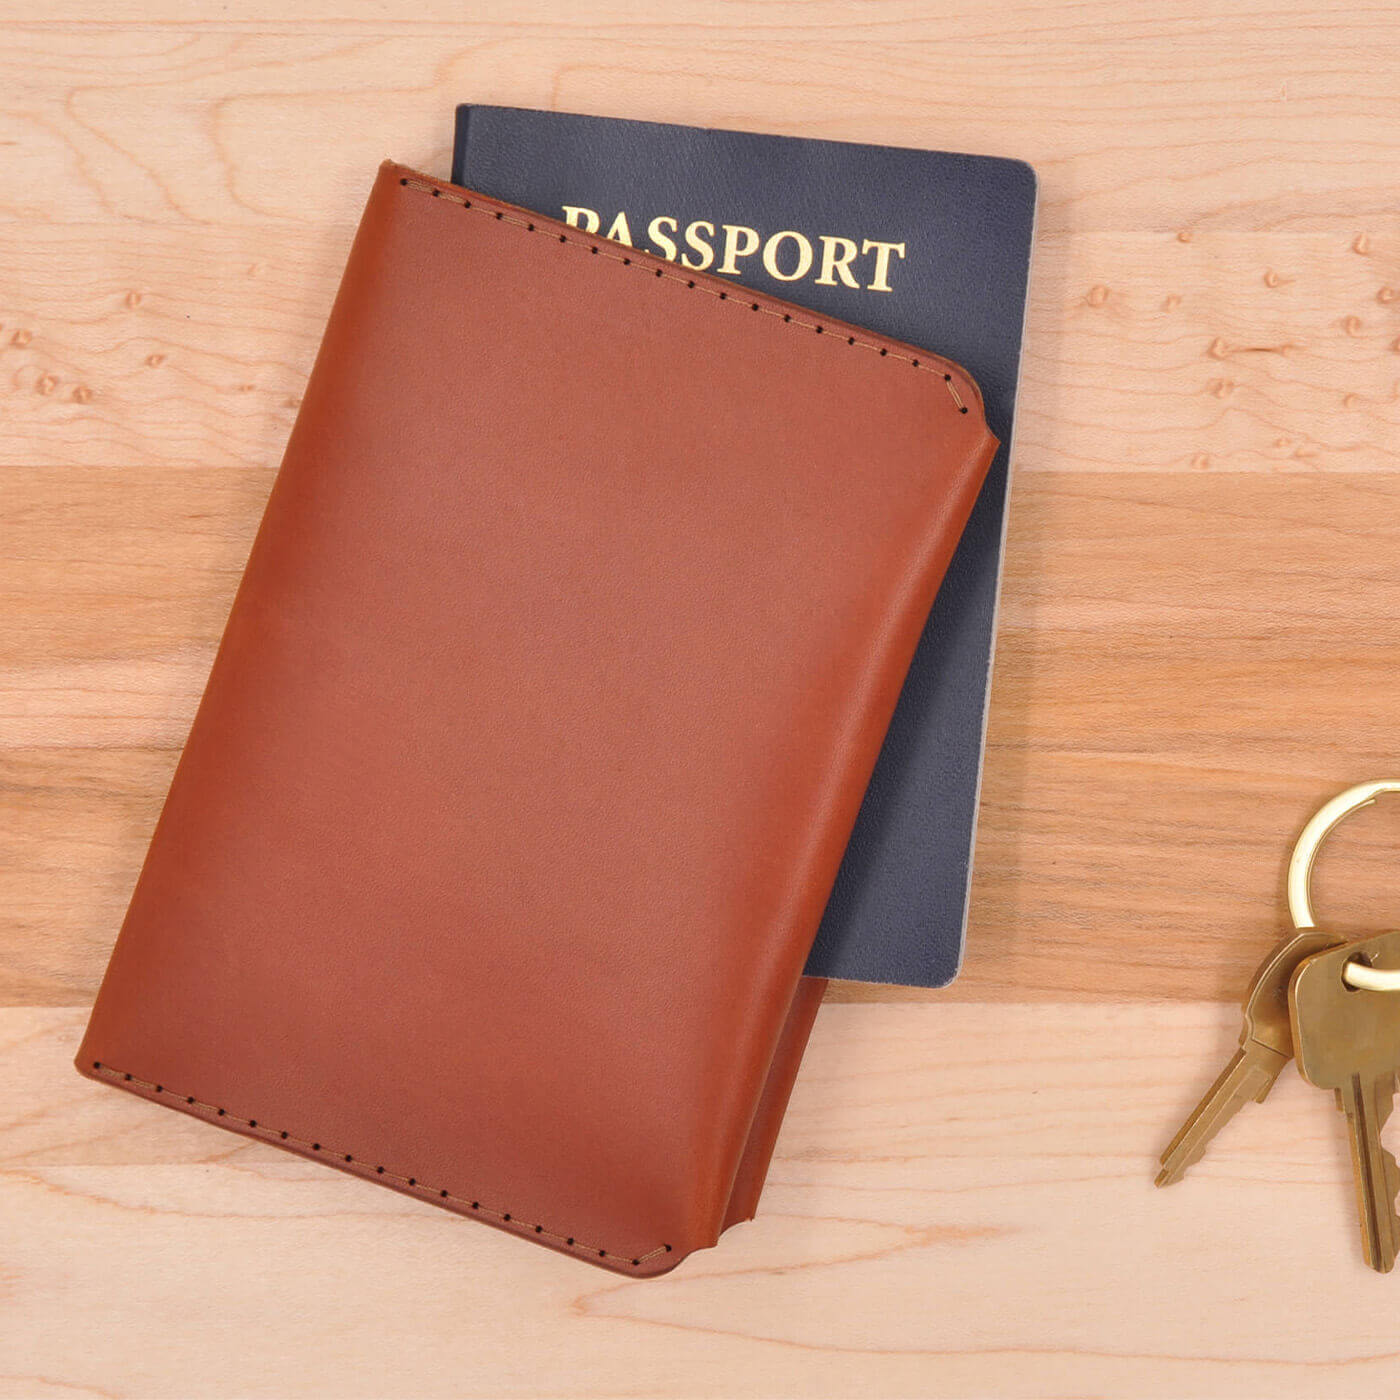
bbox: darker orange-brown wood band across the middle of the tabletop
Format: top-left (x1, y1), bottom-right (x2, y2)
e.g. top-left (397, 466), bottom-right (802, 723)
top-left (8, 468), bottom-right (1400, 1004)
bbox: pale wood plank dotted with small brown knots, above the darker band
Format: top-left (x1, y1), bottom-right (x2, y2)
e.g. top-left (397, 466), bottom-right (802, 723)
top-left (0, 226), bottom-right (1400, 475)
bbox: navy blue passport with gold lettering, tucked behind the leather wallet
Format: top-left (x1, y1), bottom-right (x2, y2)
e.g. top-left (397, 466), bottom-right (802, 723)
top-left (452, 105), bottom-right (1036, 987)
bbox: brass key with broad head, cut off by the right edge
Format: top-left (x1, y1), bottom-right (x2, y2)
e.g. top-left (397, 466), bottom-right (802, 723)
top-left (1288, 932), bottom-right (1400, 1274)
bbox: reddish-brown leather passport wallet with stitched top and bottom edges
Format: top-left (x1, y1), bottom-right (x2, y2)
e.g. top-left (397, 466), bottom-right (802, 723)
top-left (78, 165), bottom-right (995, 1274)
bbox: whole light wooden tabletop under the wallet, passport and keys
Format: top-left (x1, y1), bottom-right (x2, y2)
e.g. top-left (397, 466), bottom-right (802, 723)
top-left (0, 0), bottom-right (1400, 1400)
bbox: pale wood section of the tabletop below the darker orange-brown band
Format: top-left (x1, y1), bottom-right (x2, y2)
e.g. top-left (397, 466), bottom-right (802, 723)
top-left (8, 1005), bottom-right (1397, 1400)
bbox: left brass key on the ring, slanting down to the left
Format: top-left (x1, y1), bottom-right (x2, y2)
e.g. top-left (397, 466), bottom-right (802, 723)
top-left (1156, 928), bottom-right (1340, 1186)
